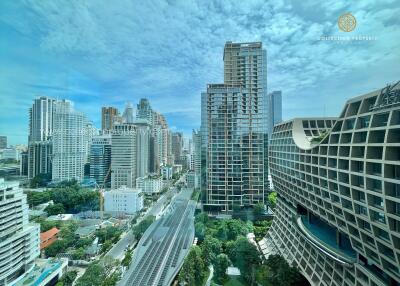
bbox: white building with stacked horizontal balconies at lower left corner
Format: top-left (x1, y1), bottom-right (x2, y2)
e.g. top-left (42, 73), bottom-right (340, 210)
top-left (0, 178), bottom-right (40, 285)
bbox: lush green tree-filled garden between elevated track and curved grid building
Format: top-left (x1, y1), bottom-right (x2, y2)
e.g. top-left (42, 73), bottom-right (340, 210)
top-left (179, 213), bottom-right (308, 286)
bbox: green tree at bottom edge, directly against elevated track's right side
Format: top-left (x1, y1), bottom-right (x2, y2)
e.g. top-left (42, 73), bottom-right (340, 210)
top-left (178, 246), bottom-right (206, 286)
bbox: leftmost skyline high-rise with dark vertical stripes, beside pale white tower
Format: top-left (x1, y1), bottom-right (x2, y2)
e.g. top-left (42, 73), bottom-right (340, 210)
top-left (28, 96), bottom-right (56, 179)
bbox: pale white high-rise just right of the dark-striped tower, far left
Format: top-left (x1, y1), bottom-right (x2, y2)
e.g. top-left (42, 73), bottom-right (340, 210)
top-left (52, 100), bottom-right (88, 181)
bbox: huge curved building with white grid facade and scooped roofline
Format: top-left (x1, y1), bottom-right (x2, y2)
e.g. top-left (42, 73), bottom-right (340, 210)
top-left (260, 83), bottom-right (400, 285)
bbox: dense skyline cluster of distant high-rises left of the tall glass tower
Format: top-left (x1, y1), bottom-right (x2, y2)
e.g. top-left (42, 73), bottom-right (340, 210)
top-left (21, 96), bottom-right (195, 192)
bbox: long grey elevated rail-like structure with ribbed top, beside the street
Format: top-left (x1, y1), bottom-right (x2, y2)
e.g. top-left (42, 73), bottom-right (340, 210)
top-left (118, 189), bottom-right (196, 286)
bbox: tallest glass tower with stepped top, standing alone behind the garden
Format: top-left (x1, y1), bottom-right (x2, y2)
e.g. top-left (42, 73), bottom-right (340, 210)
top-left (202, 42), bottom-right (268, 212)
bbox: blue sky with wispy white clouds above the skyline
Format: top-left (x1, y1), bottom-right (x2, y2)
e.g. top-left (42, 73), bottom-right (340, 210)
top-left (0, 0), bottom-right (400, 144)
